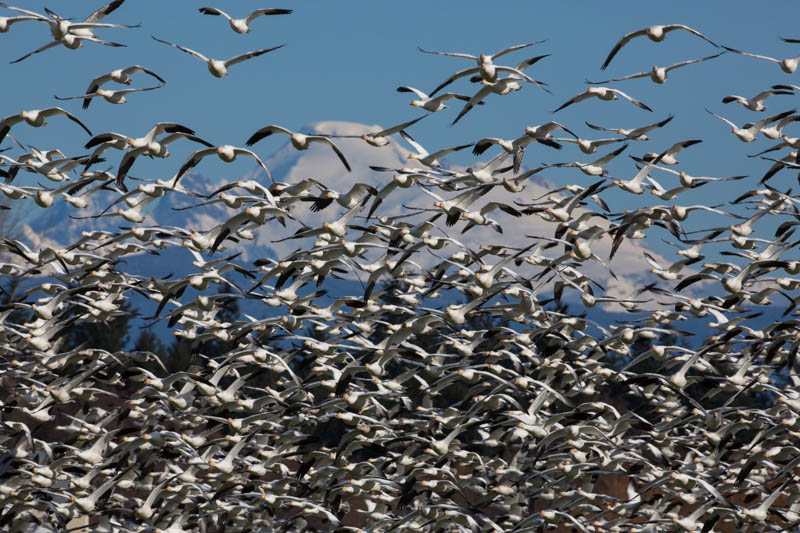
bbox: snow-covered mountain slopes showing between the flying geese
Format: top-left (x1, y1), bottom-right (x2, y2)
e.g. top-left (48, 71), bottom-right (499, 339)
top-left (15, 122), bottom-right (680, 310)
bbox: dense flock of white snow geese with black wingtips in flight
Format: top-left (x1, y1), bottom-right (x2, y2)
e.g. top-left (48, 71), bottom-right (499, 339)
top-left (0, 0), bottom-right (800, 533)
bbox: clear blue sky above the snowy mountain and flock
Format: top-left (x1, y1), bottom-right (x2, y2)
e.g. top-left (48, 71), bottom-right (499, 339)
top-left (0, 0), bottom-right (800, 218)
